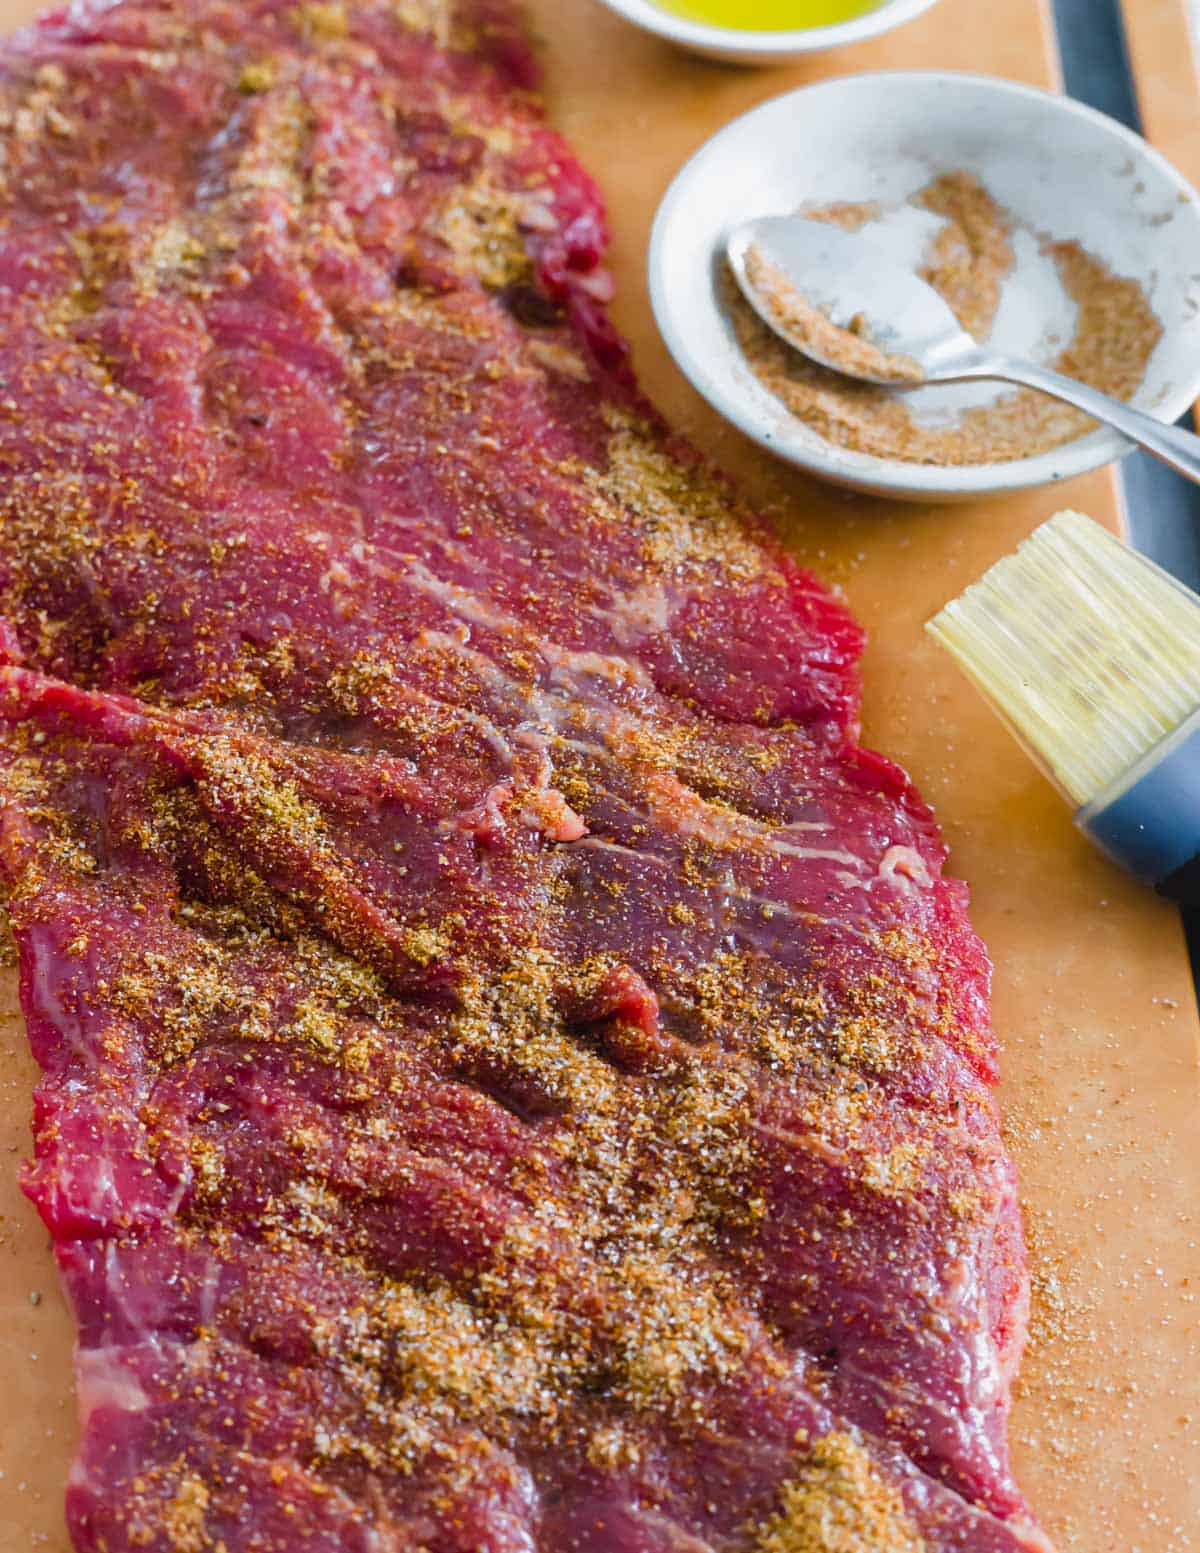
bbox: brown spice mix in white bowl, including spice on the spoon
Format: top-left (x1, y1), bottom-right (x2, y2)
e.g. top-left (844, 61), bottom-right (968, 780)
top-left (727, 172), bottom-right (1163, 464)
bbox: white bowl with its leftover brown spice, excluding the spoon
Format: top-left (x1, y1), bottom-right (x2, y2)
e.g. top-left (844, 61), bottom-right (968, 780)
top-left (650, 73), bottom-right (1200, 500)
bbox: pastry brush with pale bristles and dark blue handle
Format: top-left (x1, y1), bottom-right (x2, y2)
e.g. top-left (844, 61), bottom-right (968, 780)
top-left (925, 512), bottom-right (1200, 905)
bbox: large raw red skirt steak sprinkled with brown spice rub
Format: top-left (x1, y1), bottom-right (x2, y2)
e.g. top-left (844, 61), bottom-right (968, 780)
top-left (0, 0), bottom-right (1046, 1553)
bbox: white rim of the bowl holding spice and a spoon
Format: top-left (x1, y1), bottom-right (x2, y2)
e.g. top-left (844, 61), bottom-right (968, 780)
top-left (647, 70), bottom-right (1200, 502)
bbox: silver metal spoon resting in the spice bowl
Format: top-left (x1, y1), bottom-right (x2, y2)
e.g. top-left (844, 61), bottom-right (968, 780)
top-left (725, 216), bottom-right (1200, 485)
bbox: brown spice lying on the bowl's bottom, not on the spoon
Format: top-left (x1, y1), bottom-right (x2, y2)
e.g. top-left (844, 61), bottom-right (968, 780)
top-left (727, 172), bottom-right (1163, 464)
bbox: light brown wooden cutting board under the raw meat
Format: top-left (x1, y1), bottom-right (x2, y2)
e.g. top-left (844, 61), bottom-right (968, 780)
top-left (0, 0), bottom-right (1200, 1553)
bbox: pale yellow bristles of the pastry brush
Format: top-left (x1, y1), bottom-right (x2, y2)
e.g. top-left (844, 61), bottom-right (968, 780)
top-left (927, 512), bottom-right (1200, 808)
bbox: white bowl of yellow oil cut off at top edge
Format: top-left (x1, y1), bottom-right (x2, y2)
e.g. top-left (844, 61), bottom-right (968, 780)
top-left (601, 0), bottom-right (938, 65)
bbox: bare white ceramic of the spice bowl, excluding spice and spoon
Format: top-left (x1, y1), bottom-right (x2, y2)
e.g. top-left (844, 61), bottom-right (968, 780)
top-left (649, 71), bottom-right (1200, 502)
